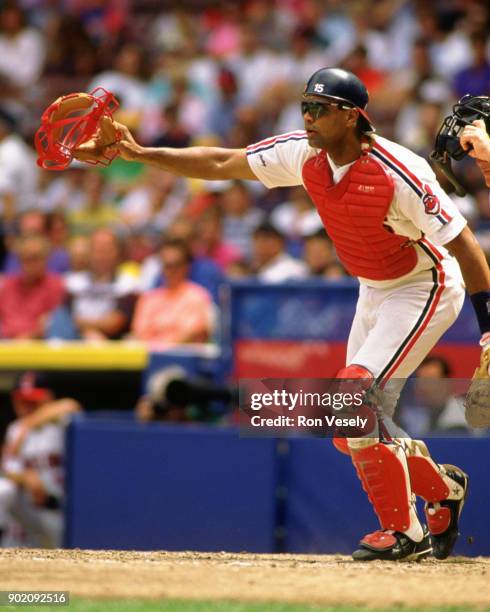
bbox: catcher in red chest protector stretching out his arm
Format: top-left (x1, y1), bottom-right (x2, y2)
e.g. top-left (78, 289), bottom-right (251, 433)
top-left (71, 68), bottom-right (490, 561)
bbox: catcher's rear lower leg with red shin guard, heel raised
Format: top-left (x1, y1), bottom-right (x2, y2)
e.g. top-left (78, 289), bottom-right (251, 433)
top-left (401, 439), bottom-right (468, 559)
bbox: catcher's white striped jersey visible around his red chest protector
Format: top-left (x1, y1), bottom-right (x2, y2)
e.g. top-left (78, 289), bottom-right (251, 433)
top-left (247, 131), bottom-right (466, 287)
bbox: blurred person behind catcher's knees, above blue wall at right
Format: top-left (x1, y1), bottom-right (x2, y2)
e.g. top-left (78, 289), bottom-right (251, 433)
top-left (398, 355), bottom-right (469, 437)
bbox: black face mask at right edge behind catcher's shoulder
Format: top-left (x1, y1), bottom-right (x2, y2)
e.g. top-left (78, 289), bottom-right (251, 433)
top-left (430, 94), bottom-right (490, 196)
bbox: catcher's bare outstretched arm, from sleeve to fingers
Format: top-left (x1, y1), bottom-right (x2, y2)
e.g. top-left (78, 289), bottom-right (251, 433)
top-left (75, 123), bottom-right (258, 180)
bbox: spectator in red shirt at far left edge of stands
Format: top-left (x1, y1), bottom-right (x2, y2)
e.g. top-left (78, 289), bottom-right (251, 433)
top-left (0, 235), bottom-right (64, 339)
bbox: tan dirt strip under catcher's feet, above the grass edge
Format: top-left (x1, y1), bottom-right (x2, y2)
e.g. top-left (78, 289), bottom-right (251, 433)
top-left (0, 549), bottom-right (490, 608)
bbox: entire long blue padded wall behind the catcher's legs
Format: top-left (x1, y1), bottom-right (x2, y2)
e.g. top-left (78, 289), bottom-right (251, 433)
top-left (65, 417), bottom-right (490, 556)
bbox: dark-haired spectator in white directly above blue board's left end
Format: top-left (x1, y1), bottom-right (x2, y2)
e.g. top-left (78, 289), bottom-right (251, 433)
top-left (252, 222), bottom-right (307, 283)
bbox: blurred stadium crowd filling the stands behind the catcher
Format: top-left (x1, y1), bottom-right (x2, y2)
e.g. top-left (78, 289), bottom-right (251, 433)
top-left (0, 0), bottom-right (490, 343)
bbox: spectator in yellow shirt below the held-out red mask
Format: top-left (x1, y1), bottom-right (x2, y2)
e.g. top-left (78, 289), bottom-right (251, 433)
top-left (68, 172), bottom-right (120, 234)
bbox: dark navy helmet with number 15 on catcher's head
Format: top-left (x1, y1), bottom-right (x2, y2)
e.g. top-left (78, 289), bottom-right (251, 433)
top-left (303, 68), bottom-right (374, 132)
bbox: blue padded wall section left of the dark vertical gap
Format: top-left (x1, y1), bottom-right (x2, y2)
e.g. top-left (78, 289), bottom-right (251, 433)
top-left (65, 418), bottom-right (277, 552)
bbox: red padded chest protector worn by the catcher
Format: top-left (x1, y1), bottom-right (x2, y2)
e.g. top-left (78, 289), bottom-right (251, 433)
top-left (303, 151), bottom-right (417, 281)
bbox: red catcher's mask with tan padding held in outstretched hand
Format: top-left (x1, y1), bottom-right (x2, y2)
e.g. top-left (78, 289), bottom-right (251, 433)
top-left (34, 87), bottom-right (120, 170)
